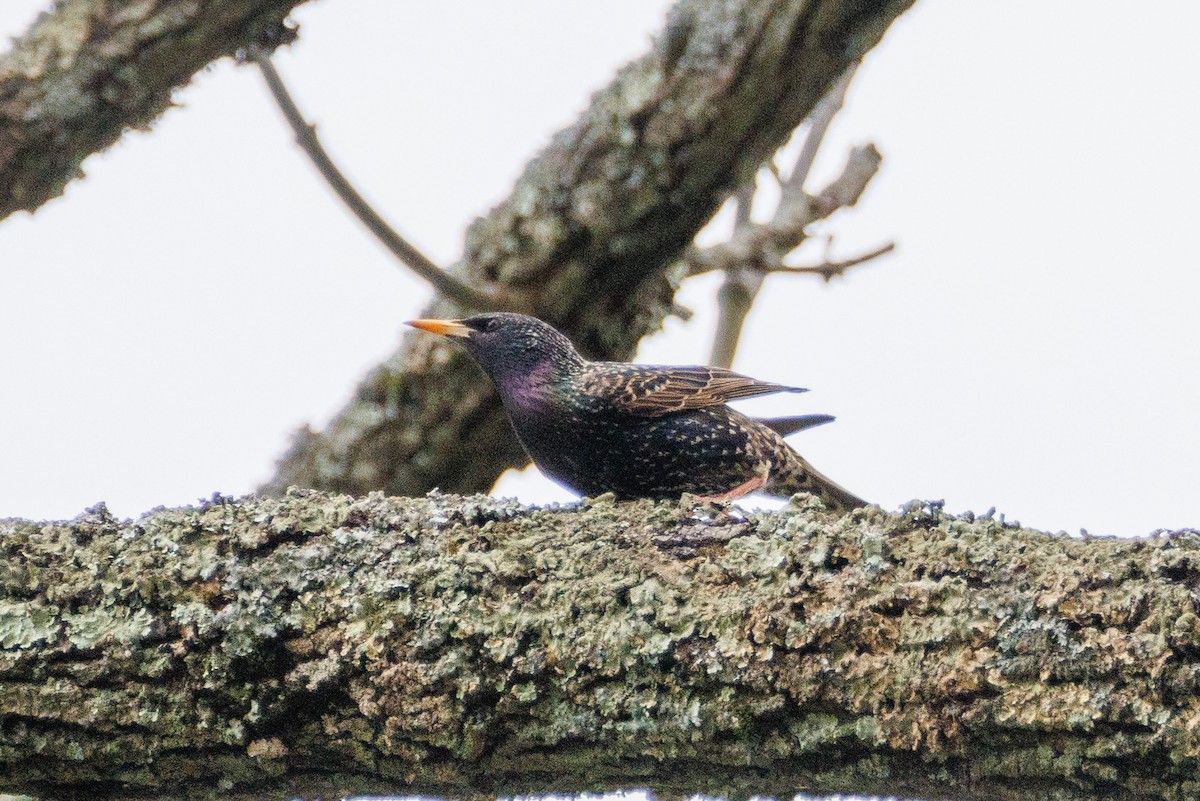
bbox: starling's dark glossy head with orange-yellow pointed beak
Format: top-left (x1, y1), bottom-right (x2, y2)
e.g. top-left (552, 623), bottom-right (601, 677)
top-left (406, 312), bottom-right (583, 396)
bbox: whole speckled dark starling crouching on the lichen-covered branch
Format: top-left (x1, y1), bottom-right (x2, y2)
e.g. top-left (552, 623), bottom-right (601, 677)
top-left (408, 313), bottom-right (866, 510)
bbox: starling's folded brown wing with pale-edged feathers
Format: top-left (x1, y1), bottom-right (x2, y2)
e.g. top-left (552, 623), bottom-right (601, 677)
top-left (583, 362), bottom-right (806, 417)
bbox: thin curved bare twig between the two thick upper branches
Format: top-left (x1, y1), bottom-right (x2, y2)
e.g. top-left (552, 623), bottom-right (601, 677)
top-left (250, 48), bottom-right (520, 309)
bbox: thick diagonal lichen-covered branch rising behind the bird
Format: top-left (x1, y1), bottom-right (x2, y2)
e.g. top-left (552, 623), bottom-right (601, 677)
top-left (264, 0), bottom-right (912, 495)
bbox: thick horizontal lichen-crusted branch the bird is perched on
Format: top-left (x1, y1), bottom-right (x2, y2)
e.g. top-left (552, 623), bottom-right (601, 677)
top-left (0, 493), bottom-right (1200, 801)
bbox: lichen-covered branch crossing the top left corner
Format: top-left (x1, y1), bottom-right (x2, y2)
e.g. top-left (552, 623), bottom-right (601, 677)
top-left (0, 0), bottom-right (304, 219)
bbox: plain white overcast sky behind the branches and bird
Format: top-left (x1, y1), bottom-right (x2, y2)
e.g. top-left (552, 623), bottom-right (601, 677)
top-left (0, 0), bottom-right (1200, 535)
